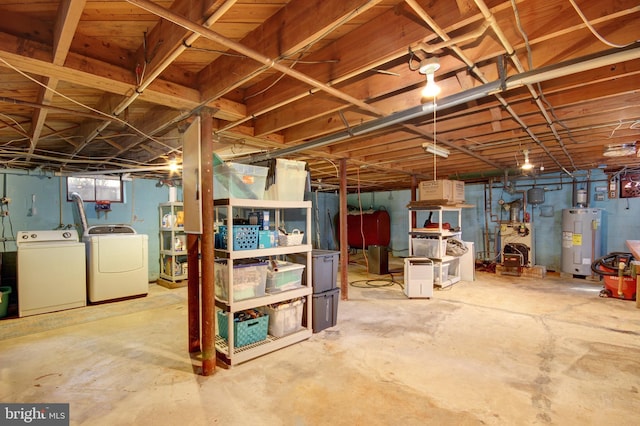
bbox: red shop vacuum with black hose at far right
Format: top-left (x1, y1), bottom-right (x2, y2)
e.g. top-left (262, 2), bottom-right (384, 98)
top-left (591, 252), bottom-right (637, 300)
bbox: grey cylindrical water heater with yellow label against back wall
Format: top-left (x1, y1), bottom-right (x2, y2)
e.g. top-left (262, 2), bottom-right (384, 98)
top-left (562, 208), bottom-right (602, 276)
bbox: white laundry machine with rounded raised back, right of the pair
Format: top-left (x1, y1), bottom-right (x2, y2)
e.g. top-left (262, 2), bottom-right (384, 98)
top-left (82, 225), bottom-right (149, 303)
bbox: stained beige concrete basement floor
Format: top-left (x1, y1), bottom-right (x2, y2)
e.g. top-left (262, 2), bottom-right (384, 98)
top-left (0, 256), bottom-right (640, 426)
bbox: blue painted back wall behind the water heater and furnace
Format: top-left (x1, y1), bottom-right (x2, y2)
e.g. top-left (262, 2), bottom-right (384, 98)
top-left (347, 170), bottom-right (640, 271)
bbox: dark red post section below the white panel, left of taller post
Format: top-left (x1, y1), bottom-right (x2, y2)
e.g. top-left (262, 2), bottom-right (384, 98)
top-left (187, 234), bottom-right (200, 353)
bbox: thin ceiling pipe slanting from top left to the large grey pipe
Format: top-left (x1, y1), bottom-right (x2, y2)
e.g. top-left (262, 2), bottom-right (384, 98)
top-left (127, 0), bottom-right (383, 115)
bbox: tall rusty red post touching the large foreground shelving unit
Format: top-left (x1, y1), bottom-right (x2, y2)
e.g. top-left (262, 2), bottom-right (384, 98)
top-left (200, 111), bottom-right (216, 376)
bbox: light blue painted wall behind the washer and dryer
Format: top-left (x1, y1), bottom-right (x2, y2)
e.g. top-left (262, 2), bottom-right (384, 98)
top-left (0, 170), bottom-right (172, 281)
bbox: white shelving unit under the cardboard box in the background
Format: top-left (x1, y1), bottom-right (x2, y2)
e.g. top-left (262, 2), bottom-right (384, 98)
top-left (408, 204), bottom-right (462, 287)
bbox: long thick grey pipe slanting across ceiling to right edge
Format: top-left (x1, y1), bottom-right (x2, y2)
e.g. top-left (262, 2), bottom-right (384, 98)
top-left (245, 42), bottom-right (640, 163)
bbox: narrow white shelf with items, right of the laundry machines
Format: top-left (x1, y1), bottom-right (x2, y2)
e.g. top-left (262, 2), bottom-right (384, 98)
top-left (159, 201), bottom-right (187, 282)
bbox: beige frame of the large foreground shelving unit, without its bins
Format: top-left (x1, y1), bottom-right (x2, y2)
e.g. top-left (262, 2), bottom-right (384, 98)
top-left (214, 198), bottom-right (313, 365)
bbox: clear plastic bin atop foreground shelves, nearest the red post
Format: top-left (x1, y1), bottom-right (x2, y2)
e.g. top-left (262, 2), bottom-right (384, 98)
top-left (213, 163), bottom-right (269, 200)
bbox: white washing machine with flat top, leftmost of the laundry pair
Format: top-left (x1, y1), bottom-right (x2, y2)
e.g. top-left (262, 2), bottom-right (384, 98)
top-left (16, 229), bottom-right (87, 317)
